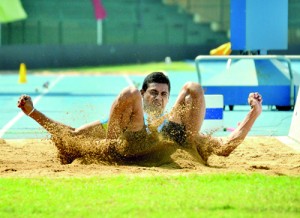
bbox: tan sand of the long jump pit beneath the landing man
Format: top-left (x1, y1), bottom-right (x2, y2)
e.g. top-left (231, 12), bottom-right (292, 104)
top-left (0, 137), bottom-right (300, 177)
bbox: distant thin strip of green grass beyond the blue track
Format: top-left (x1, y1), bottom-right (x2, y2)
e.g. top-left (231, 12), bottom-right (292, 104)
top-left (35, 62), bottom-right (196, 73)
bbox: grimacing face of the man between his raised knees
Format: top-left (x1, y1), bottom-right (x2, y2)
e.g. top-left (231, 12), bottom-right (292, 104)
top-left (141, 83), bottom-right (170, 115)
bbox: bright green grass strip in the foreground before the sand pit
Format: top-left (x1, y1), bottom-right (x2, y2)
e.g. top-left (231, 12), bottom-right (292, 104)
top-left (0, 174), bottom-right (300, 217)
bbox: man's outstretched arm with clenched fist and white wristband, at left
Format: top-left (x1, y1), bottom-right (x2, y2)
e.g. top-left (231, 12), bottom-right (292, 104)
top-left (17, 95), bottom-right (105, 138)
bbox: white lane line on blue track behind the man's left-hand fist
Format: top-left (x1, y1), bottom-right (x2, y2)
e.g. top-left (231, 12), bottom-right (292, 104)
top-left (0, 75), bottom-right (64, 138)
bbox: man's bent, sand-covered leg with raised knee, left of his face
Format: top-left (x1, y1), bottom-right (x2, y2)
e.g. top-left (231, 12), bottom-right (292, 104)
top-left (106, 87), bottom-right (159, 160)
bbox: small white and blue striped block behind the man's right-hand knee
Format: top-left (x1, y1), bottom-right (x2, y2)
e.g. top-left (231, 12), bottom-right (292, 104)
top-left (200, 95), bottom-right (224, 132)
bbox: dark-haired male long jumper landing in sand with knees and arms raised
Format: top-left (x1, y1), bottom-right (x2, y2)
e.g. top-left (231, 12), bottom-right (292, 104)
top-left (18, 72), bottom-right (262, 164)
